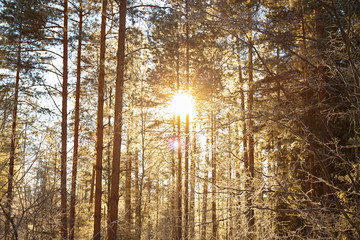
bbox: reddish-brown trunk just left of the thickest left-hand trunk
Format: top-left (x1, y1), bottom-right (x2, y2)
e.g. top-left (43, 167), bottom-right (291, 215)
top-left (94, 0), bottom-right (107, 240)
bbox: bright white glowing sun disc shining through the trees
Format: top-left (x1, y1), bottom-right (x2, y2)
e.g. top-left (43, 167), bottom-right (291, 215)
top-left (170, 93), bottom-right (195, 118)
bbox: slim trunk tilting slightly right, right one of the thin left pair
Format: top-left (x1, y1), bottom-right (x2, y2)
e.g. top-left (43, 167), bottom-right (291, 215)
top-left (69, 0), bottom-right (83, 240)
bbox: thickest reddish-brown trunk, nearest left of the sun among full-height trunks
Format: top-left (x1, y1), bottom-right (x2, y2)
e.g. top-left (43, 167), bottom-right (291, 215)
top-left (108, 0), bottom-right (126, 239)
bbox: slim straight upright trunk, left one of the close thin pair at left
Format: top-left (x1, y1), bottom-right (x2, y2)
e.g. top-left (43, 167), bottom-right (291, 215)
top-left (61, 0), bottom-right (68, 239)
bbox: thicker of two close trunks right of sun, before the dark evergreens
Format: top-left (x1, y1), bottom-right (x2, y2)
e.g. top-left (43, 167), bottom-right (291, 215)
top-left (246, 38), bottom-right (255, 239)
